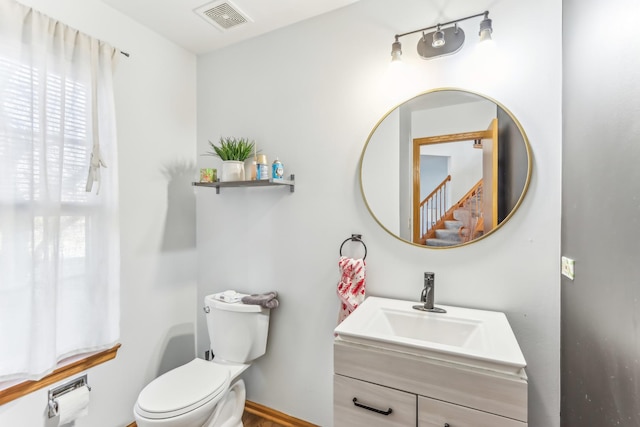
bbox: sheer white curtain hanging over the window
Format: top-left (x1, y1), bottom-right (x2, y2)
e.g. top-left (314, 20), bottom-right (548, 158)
top-left (0, 0), bottom-right (120, 381)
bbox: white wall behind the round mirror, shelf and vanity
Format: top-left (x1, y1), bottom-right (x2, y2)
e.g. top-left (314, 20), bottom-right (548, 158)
top-left (196, 0), bottom-right (561, 427)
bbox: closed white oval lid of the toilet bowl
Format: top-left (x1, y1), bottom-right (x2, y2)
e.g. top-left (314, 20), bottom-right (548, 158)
top-left (137, 359), bottom-right (230, 418)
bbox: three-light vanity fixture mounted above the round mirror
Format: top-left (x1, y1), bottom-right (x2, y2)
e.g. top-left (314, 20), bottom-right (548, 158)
top-left (391, 11), bottom-right (493, 62)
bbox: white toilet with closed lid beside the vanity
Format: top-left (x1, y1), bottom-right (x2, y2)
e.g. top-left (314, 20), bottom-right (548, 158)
top-left (133, 295), bottom-right (270, 427)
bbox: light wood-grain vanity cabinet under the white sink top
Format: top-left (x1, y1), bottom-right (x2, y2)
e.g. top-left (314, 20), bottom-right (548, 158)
top-left (333, 337), bottom-right (527, 427)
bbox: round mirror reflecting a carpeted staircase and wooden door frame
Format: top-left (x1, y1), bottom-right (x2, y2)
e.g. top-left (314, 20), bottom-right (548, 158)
top-left (360, 89), bottom-right (532, 248)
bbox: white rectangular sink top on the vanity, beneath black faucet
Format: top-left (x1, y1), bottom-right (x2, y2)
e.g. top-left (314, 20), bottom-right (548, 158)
top-left (335, 297), bottom-right (527, 373)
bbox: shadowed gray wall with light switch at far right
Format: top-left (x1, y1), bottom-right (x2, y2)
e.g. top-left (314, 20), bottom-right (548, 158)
top-left (561, 0), bottom-right (640, 427)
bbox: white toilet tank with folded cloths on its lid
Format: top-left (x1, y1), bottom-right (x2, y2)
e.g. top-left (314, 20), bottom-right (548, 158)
top-left (204, 295), bottom-right (271, 363)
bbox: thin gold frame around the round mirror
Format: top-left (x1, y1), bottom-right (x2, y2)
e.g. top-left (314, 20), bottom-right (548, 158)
top-left (359, 87), bottom-right (533, 249)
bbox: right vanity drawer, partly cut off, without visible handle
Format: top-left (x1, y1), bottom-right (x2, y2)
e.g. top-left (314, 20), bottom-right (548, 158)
top-left (418, 396), bottom-right (527, 427)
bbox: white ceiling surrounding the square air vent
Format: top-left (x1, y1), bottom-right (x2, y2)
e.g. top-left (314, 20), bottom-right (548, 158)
top-left (102, 0), bottom-right (358, 54)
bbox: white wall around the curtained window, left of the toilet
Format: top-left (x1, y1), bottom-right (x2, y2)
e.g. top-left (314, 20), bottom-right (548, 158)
top-left (0, 0), bottom-right (196, 427)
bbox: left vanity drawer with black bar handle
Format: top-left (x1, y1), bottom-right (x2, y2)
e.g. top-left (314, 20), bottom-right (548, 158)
top-left (333, 375), bottom-right (417, 427)
